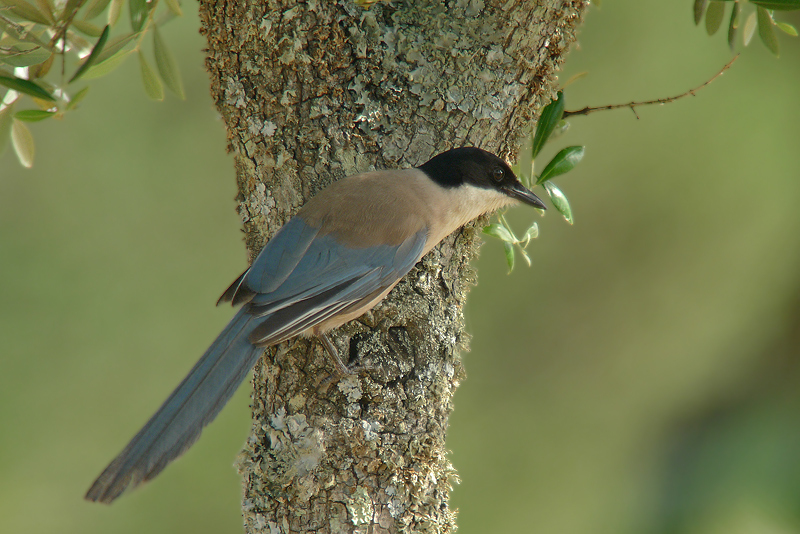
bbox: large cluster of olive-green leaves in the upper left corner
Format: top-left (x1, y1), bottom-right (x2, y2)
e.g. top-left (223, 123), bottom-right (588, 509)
top-left (0, 0), bottom-right (185, 167)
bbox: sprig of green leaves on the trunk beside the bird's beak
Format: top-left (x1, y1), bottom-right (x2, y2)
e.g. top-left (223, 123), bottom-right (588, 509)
top-left (483, 91), bottom-right (585, 273)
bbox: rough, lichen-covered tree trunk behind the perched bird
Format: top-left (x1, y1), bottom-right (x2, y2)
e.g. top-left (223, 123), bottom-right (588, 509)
top-left (200, 0), bottom-right (587, 533)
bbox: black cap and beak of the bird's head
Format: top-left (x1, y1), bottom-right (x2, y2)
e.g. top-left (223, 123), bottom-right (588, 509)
top-left (419, 147), bottom-right (546, 209)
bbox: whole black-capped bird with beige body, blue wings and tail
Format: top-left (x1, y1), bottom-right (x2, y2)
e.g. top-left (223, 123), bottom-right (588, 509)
top-left (85, 147), bottom-right (546, 503)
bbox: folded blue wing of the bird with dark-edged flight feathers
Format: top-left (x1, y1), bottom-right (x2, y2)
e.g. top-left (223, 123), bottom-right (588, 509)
top-left (220, 217), bottom-right (427, 345)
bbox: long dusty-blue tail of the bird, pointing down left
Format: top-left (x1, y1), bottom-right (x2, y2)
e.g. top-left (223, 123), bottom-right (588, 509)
top-left (86, 309), bottom-right (264, 503)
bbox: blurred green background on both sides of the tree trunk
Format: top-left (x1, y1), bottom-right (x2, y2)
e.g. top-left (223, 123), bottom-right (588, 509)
top-left (0, 0), bottom-right (800, 534)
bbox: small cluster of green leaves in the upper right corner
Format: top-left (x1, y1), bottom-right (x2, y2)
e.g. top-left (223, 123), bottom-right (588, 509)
top-left (694, 0), bottom-right (800, 57)
